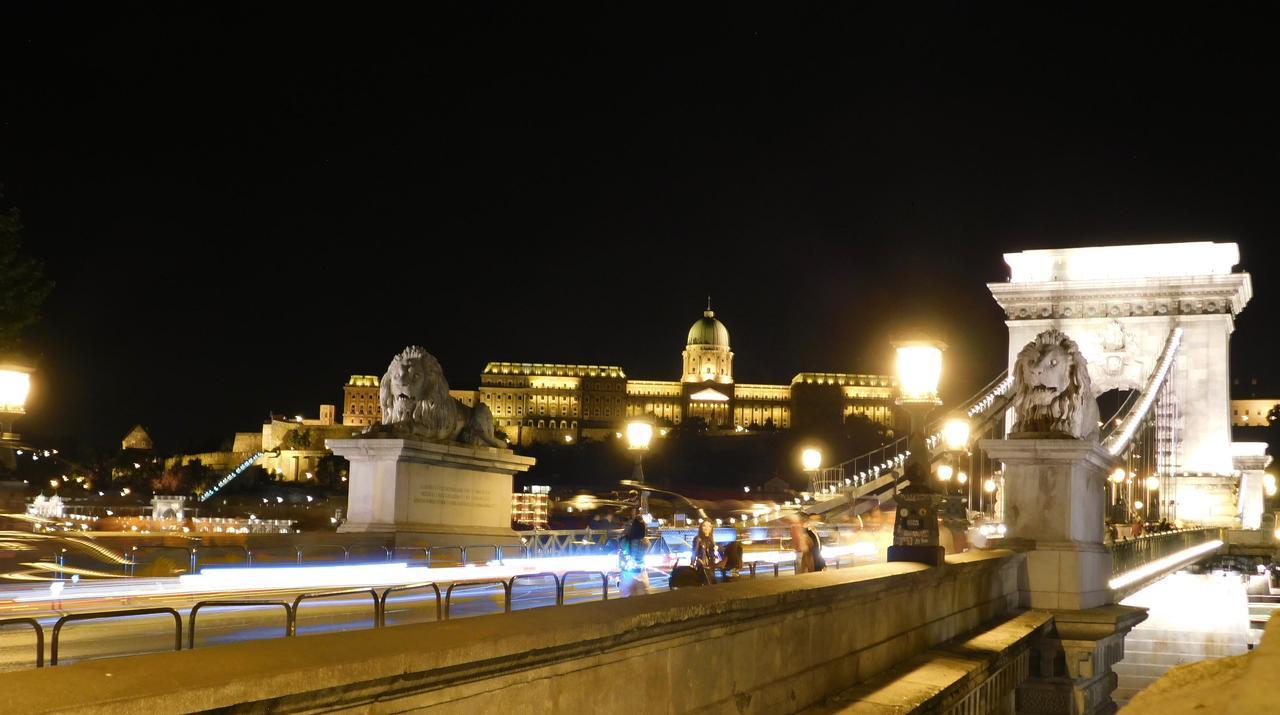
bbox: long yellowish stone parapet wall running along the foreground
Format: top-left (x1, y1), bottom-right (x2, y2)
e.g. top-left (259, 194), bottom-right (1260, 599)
top-left (0, 551), bottom-right (1023, 715)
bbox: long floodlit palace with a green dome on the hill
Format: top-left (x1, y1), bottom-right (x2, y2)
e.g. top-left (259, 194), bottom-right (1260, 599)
top-left (343, 306), bottom-right (896, 444)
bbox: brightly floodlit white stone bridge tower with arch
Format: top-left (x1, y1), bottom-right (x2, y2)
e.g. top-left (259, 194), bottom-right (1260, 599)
top-left (988, 242), bottom-right (1261, 526)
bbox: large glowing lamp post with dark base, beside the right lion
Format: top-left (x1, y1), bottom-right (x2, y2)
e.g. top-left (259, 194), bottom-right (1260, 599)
top-left (888, 340), bottom-right (946, 565)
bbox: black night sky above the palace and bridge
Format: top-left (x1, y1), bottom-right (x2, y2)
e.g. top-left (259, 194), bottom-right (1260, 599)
top-left (0, 1), bottom-right (1280, 450)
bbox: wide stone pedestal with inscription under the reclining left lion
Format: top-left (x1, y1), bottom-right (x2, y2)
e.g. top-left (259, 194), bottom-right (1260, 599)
top-left (325, 439), bottom-right (534, 546)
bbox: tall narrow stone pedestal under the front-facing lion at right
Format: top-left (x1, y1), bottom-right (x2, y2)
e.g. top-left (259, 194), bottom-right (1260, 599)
top-left (982, 439), bottom-right (1114, 610)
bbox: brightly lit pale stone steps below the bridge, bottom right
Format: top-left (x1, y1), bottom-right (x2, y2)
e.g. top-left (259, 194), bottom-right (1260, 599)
top-left (1112, 572), bottom-right (1252, 705)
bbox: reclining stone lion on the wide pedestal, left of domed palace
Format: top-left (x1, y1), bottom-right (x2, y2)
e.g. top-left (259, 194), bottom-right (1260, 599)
top-left (365, 345), bottom-right (507, 448)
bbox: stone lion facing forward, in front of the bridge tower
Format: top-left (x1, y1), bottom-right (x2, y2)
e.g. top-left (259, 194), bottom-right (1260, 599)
top-left (1010, 329), bottom-right (1098, 441)
